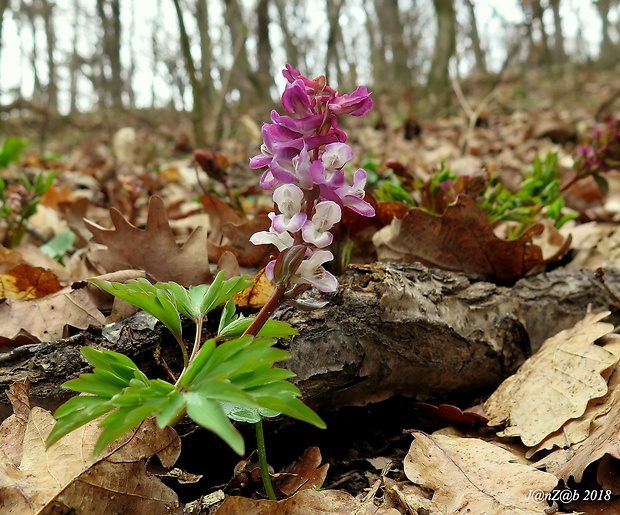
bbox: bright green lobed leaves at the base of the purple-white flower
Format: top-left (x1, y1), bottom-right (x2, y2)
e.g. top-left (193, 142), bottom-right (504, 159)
top-left (47, 272), bottom-right (325, 460)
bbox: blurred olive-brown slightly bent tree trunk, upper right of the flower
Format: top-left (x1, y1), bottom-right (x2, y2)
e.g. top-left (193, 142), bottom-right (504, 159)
top-left (426, 0), bottom-right (456, 108)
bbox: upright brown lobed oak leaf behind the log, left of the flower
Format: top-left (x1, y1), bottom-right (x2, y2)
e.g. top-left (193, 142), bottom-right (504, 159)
top-left (86, 196), bottom-right (213, 286)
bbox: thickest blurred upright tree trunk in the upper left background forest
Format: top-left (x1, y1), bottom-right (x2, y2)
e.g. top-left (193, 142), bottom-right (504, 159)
top-left (97, 0), bottom-right (123, 109)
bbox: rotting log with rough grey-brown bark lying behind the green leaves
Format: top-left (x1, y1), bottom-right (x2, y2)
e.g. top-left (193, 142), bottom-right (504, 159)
top-left (0, 263), bottom-right (620, 418)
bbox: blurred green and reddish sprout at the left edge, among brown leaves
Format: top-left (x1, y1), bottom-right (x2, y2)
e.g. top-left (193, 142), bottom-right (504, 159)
top-left (0, 172), bottom-right (58, 248)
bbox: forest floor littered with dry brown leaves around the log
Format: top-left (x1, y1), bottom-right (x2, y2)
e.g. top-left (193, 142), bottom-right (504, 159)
top-left (0, 68), bottom-right (620, 515)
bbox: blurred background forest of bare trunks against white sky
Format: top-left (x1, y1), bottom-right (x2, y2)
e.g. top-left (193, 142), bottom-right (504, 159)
top-left (0, 0), bottom-right (620, 147)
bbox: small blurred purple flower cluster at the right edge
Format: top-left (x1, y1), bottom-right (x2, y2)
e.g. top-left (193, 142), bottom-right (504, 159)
top-left (575, 120), bottom-right (620, 177)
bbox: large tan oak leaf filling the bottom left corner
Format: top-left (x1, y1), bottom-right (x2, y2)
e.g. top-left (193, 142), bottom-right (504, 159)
top-left (0, 376), bottom-right (181, 515)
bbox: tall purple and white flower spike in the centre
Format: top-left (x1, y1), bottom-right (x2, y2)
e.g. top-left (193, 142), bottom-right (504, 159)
top-left (250, 64), bottom-right (374, 292)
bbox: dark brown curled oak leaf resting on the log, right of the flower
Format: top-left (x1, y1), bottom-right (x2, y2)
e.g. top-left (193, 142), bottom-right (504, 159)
top-left (373, 196), bottom-right (570, 282)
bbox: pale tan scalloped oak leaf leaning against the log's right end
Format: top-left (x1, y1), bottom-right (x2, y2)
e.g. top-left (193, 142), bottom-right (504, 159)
top-left (484, 311), bottom-right (618, 447)
